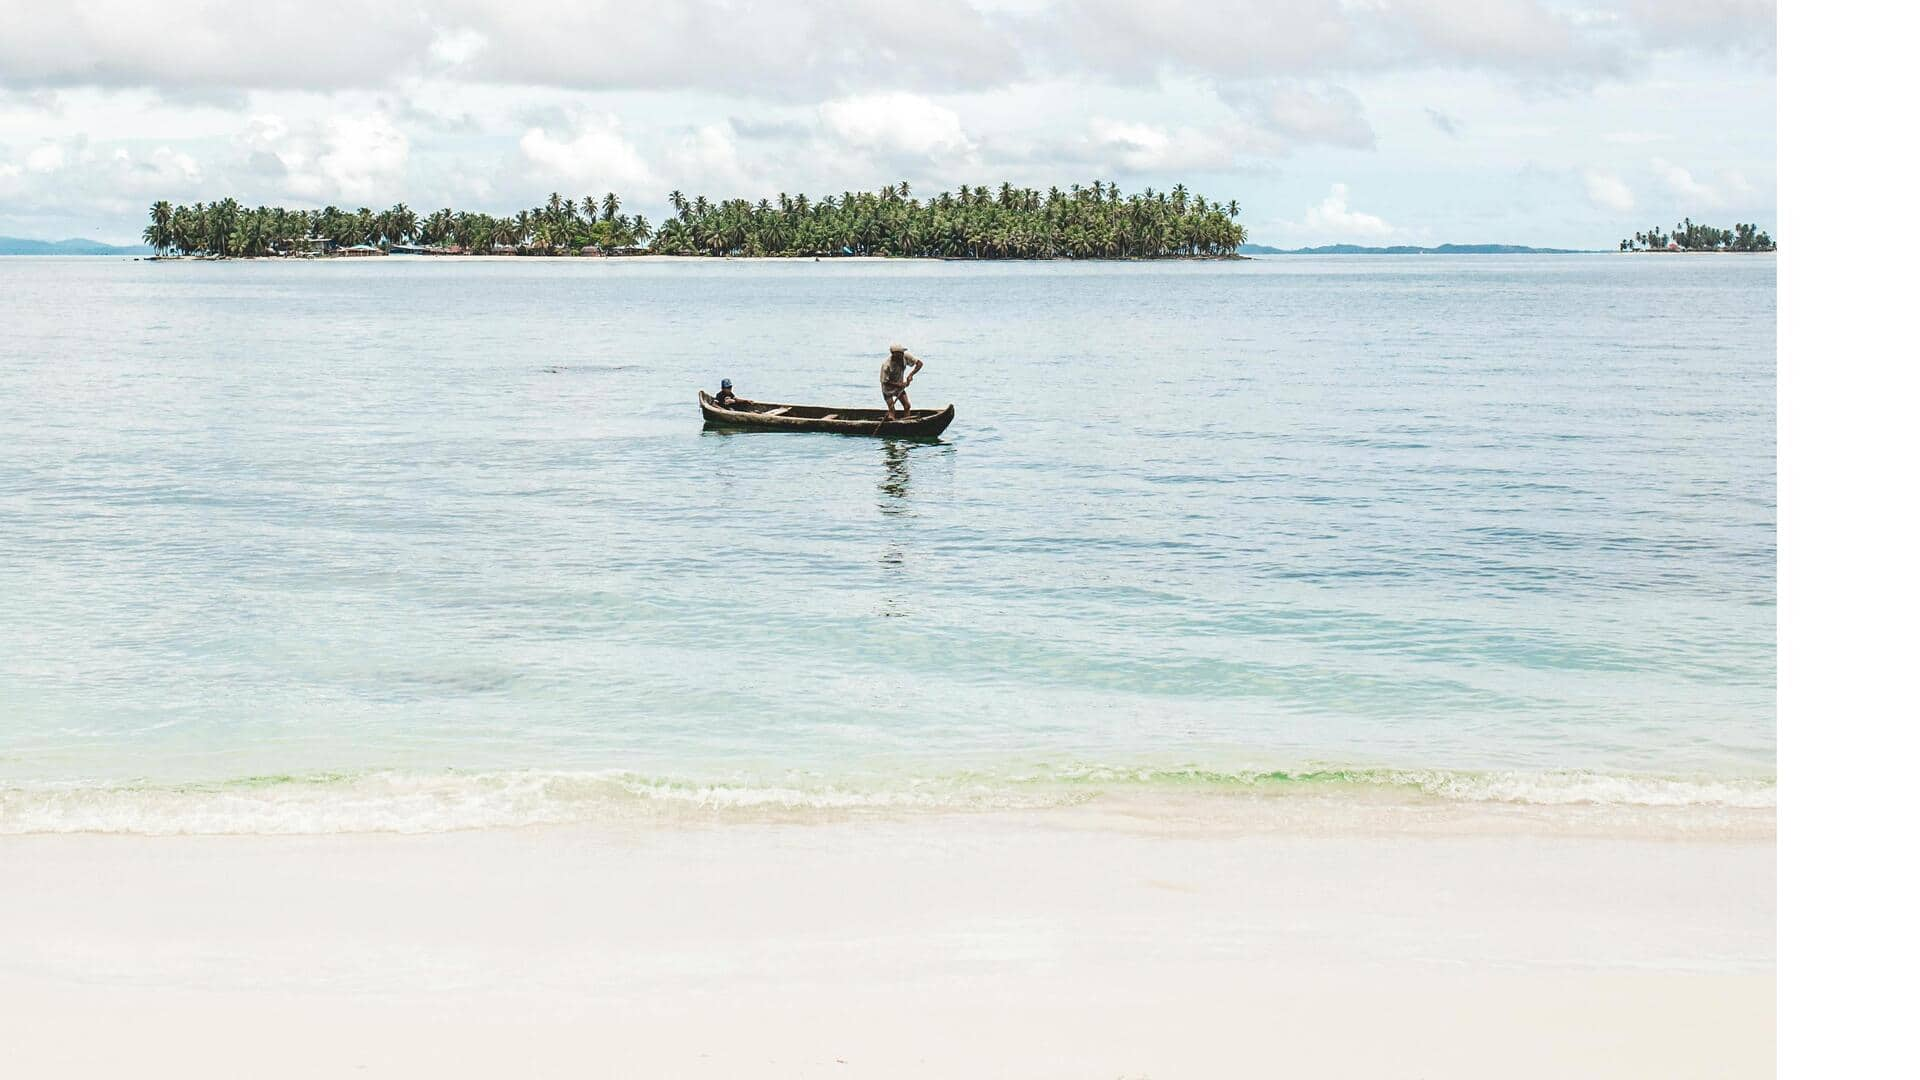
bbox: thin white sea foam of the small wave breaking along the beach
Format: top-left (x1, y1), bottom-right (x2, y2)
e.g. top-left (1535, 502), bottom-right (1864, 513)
top-left (0, 767), bottom-right (1774, 836)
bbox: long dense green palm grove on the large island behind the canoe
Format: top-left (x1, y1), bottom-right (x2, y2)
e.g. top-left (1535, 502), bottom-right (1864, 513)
top-left (144, 181), bottom-right (1246, 259)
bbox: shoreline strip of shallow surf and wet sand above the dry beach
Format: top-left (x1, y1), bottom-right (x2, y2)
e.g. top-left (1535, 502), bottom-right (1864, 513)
top-left (0, 767), bottom-right (1776, 842)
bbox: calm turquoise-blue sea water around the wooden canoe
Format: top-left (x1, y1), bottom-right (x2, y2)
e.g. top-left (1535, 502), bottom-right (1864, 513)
top-left (0, 256), bottom-right (1774, 828)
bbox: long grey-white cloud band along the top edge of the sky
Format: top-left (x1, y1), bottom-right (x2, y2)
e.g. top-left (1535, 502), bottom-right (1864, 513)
top-left (0, 0), bottom-right (1774, 102)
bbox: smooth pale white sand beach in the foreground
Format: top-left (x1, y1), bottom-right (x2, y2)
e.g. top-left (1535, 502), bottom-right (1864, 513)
top-left (0, 809), bottom-right (1774, 1078)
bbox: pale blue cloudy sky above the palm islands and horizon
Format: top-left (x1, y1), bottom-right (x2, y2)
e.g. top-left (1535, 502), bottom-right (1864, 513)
top-left (0, 0), bottom-right (1776, 248)
